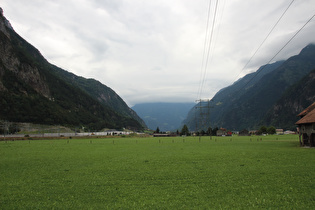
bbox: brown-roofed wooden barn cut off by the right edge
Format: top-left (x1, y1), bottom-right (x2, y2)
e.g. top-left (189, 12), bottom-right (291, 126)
top-left (295, 102), bottom-right (315, 147)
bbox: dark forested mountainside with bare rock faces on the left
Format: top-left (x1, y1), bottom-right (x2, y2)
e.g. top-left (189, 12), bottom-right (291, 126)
top-left (0, 9), bottom-right (145, 130)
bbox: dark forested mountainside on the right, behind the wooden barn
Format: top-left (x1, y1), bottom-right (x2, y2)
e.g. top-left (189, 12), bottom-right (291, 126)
top-left (182, 44), bottom-right (315, 131)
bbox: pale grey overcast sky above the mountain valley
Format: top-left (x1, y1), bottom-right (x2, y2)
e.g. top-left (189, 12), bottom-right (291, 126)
top-left (0, 0), bottom-right (315, 106)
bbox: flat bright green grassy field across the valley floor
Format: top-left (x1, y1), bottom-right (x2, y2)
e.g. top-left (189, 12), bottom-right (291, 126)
top-left (0, 135), bottom-right (315, 209)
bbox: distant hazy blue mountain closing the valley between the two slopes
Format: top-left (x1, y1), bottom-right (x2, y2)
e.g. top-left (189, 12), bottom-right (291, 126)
top-left (132, 103), bottom-right (195, 131)
